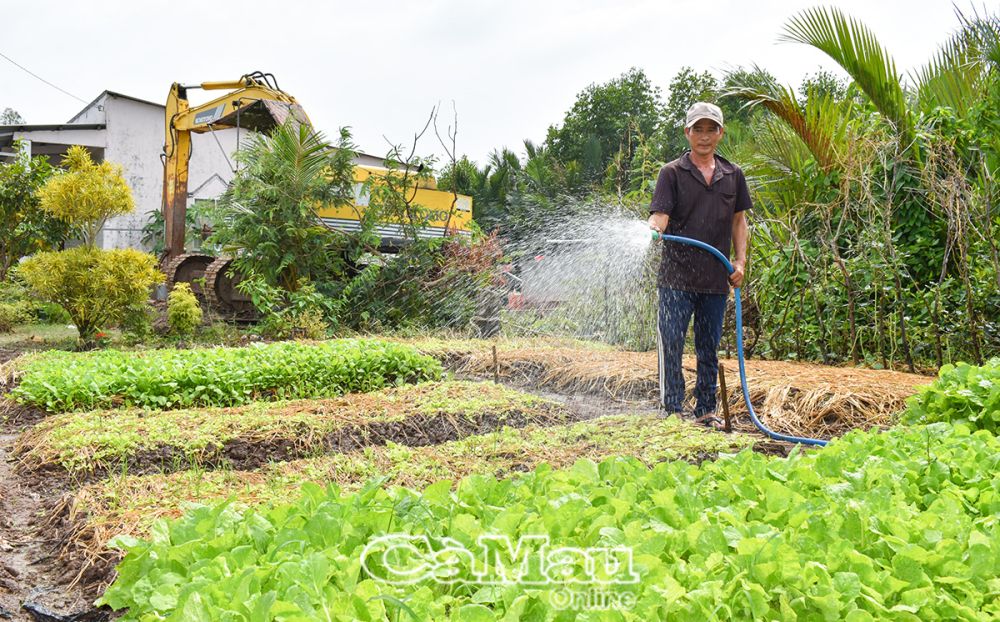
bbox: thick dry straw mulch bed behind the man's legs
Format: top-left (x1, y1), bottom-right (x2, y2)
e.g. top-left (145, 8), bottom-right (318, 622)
top-left (453, 342), bottom-right (933, 438)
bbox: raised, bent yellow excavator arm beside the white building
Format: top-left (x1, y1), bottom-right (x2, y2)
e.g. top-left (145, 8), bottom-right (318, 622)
top-left (162, 72), bottom-right (309, 262)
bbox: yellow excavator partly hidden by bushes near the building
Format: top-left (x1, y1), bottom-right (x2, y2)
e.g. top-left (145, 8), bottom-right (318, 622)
top-left (161, 71), bottom-right (472, 318)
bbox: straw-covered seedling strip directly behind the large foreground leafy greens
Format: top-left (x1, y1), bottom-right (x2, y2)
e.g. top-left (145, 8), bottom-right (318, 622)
top-left (72, 415), bottom-right (753, 549)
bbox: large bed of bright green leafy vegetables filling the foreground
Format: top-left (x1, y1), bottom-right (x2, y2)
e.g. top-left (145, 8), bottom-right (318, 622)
top-left (95, 424), bottom-right (1000, 622)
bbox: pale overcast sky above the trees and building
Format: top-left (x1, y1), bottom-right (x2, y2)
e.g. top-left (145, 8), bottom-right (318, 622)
top-left (0, 0), bottom-right (964, 162)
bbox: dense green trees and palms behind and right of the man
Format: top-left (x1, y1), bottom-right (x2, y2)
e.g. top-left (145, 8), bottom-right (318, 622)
top-left (441, 8), bottom-right (1000, 370)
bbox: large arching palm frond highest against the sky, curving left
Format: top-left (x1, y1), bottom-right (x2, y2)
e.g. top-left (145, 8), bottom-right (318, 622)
top-left (780, 8), bottom-right (913, 144)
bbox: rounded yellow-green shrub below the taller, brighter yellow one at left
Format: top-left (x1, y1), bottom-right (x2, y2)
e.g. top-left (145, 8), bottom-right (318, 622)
top-left (18, 246), bottom-right (163, 344)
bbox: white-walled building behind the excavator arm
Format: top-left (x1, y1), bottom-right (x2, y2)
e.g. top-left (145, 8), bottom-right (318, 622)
top-left (0, 91), bottom-right (238, 250)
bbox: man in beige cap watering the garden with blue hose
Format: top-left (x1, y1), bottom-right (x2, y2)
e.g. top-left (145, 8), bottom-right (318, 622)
top-left (649, 102), bottom-right (751, 429)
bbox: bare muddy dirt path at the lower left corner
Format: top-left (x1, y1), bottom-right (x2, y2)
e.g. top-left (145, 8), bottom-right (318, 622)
top-left (0, 434), bottom-right (107, 622)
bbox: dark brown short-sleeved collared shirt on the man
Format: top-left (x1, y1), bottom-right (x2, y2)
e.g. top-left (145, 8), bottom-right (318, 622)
top-left (649, 152), bottom-right (752, 294)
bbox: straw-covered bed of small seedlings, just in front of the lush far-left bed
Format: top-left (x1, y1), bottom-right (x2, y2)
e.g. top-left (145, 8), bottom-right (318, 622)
top-left (15, 381), bottom-right (569, 475)
